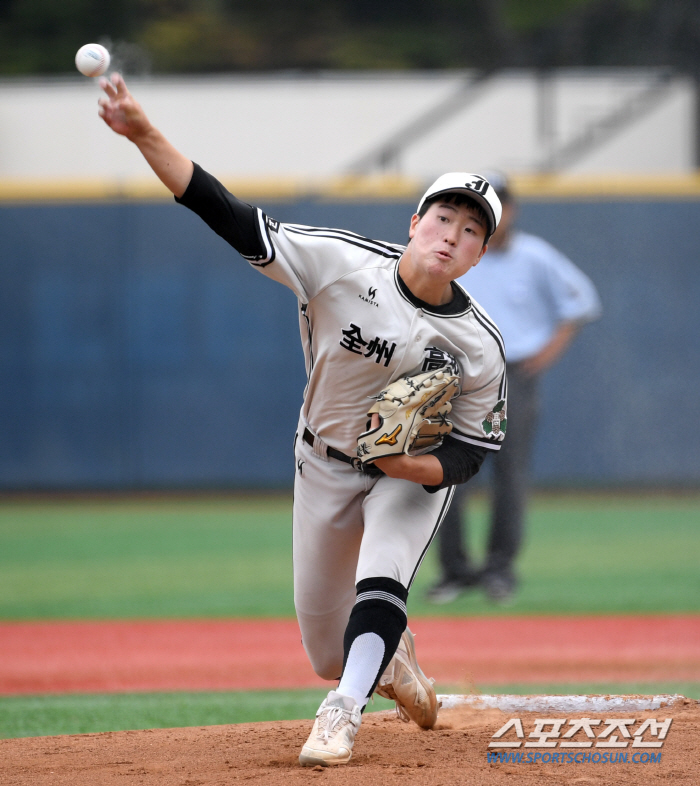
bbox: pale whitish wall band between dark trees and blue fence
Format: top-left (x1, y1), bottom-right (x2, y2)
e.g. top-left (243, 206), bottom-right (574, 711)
top-left (0, 69), bottom-right (697, 184)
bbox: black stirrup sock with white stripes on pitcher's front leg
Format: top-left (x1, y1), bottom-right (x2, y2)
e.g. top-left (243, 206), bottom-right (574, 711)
top-left (343, 577), bottom-right (408, 698)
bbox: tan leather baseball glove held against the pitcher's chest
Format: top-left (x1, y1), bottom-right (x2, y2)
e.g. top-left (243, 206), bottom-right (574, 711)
top-left (357, 366), bottom-right (460, 466)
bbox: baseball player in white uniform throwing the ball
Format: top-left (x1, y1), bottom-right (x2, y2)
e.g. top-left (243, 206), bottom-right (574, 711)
top-left (99, 74), bottom-right (507, 766)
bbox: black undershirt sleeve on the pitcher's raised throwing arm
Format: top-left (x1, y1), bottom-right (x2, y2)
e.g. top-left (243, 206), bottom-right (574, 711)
top-left (175, 162), bottom-right (266, 259)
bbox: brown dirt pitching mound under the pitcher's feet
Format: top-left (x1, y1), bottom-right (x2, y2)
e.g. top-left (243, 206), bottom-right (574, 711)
top-left (0, 699), bottom-right (700, 786)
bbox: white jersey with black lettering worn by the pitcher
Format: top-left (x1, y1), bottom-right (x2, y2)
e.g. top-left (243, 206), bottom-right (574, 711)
top-left (248, 216), bottom-right (506, 455)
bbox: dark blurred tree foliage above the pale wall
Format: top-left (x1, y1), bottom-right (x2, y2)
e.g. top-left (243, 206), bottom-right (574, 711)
top-left (0, 0), bottom-right (700, 76)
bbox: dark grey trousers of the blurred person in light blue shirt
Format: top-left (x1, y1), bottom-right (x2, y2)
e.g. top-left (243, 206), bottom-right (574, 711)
top-left (438, 363), bottom-right (539, 584)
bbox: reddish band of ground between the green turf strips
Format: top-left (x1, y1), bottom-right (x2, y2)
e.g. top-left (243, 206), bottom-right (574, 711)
top-left (0, 615), bottom-right (700, 695)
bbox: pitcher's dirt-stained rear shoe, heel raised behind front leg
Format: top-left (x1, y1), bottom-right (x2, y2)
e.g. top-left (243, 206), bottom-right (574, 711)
top-left (374, 628), bottom-right (439, 729)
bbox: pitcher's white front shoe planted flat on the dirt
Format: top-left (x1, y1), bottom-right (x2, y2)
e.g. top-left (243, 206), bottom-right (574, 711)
top-left (299, 690), bottom-right (362, 767)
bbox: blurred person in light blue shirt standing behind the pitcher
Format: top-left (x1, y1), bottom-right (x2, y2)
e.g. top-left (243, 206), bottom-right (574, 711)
top-left (427, 173), bottom-right (601, 603)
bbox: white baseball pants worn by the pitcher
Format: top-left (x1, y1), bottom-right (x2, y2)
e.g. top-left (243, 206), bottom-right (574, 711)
top-left (293, 423), bottom-right (453, 680)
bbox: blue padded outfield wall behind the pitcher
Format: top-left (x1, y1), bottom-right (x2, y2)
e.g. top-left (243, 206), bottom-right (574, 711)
top-left (0, 199), bottom-right (700, 489)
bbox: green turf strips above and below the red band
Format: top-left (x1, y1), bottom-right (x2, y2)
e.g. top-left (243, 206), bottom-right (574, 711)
top-left (0, 494), bottom-right (700, 737)
